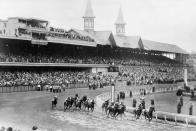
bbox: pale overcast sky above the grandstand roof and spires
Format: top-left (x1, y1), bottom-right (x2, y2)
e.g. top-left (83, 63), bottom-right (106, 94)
top-left (0, 0), bottom-right (196, 52)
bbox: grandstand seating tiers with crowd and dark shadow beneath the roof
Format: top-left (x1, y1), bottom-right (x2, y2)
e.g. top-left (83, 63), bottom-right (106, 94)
top-left (0, 37), bottom-right (196, 86)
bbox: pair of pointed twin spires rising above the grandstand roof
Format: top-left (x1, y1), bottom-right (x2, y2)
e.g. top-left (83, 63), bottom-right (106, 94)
top-left (83, 0), bottom-right (126, 36)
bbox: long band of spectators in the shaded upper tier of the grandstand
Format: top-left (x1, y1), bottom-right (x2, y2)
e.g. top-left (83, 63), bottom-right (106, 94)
top-left (0, 53), bottom-right (180, 66)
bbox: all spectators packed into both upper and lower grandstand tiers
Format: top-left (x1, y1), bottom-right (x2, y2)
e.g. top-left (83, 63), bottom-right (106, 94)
top-left (0, 49), bottom-right (196, 88)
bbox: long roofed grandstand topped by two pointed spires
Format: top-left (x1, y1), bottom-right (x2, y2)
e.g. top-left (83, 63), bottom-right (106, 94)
top-left (0, 2), bottom-right (195, 91)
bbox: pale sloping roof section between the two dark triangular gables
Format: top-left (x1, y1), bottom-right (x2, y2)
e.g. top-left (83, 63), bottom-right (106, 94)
top-left (114, 35), bottom-right (143, 48)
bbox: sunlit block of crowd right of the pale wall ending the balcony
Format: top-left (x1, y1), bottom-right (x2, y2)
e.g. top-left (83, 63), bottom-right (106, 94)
top-left (119, 65), bottom-right (184, 85)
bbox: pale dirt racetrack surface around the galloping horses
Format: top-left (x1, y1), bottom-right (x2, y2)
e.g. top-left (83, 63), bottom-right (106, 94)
top-left (0, 88), bottom-right (196, 131)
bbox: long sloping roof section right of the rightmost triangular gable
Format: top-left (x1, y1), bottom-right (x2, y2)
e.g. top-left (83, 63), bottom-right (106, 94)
top-left (142, 39), bottom-right (187, 54)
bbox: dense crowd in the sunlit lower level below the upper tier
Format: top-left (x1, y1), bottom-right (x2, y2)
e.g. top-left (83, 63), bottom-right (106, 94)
top-left (0, 65), bottom-right (194, 89)
